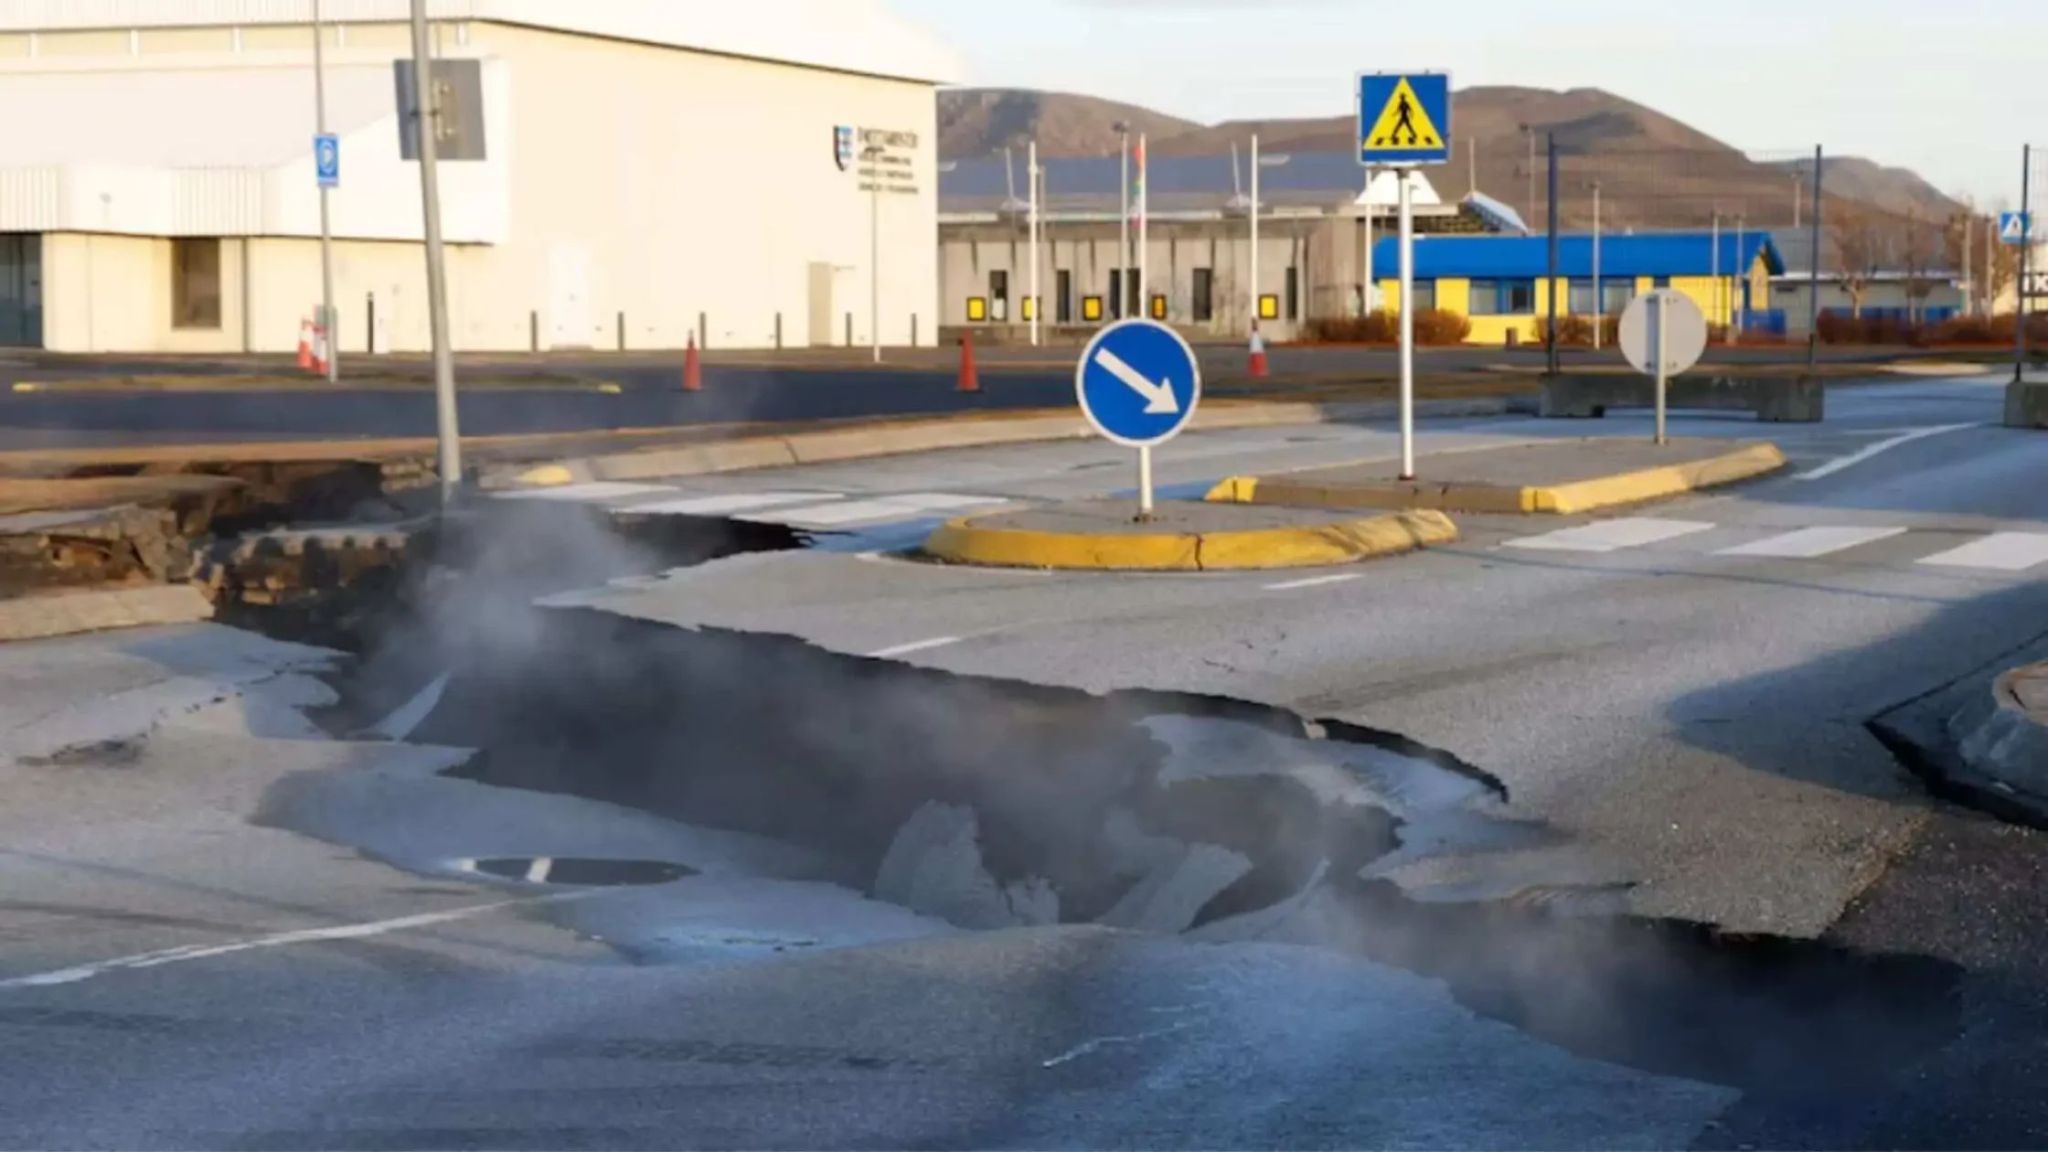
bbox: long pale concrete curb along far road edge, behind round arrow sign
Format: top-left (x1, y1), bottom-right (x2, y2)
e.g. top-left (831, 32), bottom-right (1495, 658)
top-left (481, 398), bottom-right (1511, 490)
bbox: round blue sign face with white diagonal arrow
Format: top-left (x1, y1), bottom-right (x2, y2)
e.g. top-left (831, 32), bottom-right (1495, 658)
top-left (1073, 320), bottom-right (1202, 447)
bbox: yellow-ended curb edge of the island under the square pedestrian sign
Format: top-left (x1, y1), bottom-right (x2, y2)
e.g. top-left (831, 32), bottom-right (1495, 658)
top-left (1206, 443), bottom-right (1786, 515)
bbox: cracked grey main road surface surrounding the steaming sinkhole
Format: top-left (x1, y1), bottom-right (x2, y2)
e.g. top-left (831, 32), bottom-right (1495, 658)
top-left (0, 381), bottom-right (2048, 1148)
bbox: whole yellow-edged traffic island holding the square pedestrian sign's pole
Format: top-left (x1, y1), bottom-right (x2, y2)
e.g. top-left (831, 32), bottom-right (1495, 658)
top-left (1208, 439), bottom-right (1786, 515)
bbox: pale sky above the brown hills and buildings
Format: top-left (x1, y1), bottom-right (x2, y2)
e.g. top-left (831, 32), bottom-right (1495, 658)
top-left (887, 0), bottom-right (2048, 205)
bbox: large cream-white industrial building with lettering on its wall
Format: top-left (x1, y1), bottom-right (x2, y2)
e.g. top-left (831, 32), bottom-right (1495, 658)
top-left (0, 0), bottom-right (956, 353)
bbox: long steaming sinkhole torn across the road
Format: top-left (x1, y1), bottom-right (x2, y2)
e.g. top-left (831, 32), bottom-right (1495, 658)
top-left (264, 500), bottom-right (1960, 1099)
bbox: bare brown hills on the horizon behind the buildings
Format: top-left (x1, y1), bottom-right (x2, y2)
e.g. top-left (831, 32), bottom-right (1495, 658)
top-left (938, 88), bottom-right (1964, 232)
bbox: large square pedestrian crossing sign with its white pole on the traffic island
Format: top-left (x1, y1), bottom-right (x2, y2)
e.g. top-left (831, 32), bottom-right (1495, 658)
top-left (1358, 72), bottom-right (1450, 480)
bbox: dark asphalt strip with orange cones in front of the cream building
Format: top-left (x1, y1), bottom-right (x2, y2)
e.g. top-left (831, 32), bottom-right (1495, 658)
top-left (0, 344), bottom-right (2007, 451)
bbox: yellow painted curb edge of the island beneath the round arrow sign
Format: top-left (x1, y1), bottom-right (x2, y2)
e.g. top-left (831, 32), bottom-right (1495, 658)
top-left (924, 510), bottom-right (1458, 572)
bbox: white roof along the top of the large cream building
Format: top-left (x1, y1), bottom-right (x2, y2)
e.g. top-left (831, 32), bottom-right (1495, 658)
top-left (0, 0), bottom-right (961, 84)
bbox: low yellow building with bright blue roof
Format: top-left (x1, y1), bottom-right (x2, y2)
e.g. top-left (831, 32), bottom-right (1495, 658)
top-left (1372, 232), bottom-right (1784, 344)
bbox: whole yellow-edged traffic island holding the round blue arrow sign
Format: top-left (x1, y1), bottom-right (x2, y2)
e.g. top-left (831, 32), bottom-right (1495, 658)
top-left (924, 500), bottom-right (1458, 572)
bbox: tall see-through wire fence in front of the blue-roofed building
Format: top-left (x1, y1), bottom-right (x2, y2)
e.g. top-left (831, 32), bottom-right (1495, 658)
top-left (1530, 129), bottom-right (2048, 363)
